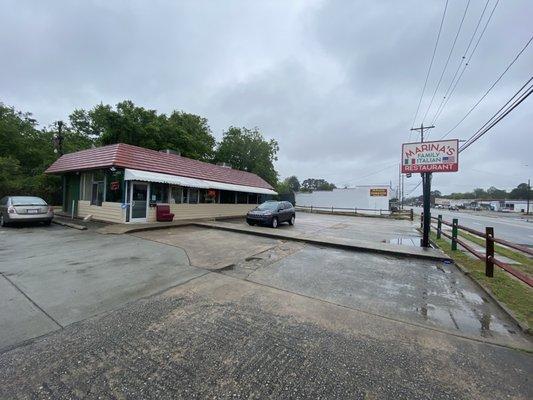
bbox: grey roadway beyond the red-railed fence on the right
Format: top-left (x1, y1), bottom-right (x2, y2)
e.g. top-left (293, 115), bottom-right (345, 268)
top-left (415, 208), bottom-right (533, 246)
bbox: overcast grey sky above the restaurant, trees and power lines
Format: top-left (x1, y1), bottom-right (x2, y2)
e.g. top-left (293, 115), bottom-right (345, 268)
top-left (0, 0), bottom-right (533, 194)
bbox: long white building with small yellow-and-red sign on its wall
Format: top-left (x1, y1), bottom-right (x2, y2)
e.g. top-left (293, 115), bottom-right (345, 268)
top-left (295, 185), bottom-right (391, 213)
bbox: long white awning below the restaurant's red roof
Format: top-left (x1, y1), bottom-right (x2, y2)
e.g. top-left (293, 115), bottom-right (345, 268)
top-left (124, 168), bottom-right (277, 194)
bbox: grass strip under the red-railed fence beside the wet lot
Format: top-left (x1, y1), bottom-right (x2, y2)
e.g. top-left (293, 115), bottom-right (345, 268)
top-left (430, 232), bottom-right (533, 327)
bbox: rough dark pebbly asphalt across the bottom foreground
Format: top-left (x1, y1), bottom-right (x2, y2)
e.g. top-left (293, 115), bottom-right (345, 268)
top-left (0, 273), bottom-right (533, 399)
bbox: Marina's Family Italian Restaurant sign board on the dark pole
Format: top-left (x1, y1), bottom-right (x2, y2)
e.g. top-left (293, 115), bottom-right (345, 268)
top-left (402, 139), bottom-right (459, 174)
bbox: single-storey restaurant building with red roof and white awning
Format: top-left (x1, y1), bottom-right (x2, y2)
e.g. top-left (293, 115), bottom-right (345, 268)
top-left (45, 143), bottom-right (277, 223)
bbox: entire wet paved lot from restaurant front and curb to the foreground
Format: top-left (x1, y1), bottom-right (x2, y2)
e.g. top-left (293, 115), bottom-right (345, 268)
top-left (0, 216), bottom-right (533, 399)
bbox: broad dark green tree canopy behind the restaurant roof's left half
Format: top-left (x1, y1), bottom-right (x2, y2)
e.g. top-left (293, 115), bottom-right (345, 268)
top-left (69, 101), bottom-right (215, 161)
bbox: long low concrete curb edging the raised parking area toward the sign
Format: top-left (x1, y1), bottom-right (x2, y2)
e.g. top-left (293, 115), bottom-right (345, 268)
top-left (191, 222), bottom-right (451, 261)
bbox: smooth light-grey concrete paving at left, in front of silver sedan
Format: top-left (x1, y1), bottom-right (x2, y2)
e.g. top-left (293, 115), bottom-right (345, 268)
top-left (0, 225), bottom-right (205, 350)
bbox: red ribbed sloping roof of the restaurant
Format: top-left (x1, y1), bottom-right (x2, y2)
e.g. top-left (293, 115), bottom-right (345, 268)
top-left (45, 143), bottom-right (273, 189)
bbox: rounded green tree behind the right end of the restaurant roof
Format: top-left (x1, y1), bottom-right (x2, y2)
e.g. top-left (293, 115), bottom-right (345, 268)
top-left (215, 126), bottom-right (279, 187)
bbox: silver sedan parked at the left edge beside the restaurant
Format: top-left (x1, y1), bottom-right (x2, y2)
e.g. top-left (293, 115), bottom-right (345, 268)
top-left (0, 196), bottom-right (54, 226)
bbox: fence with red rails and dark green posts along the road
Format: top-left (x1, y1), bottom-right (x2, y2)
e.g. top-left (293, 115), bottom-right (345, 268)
top-left (420, 213), bottom-right (533, 287)
